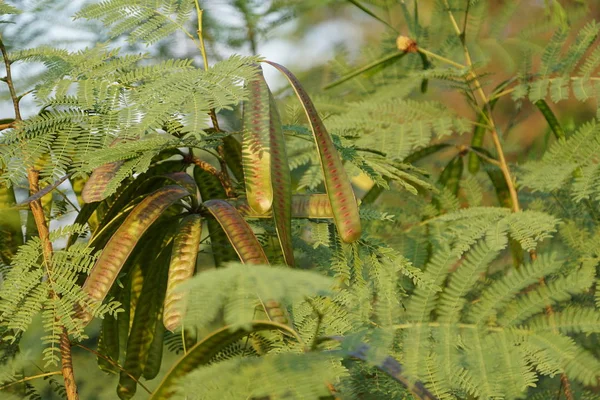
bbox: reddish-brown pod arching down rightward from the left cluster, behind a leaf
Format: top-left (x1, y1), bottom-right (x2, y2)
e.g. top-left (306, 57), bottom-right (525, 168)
top-left (204, 200), bottom-right (269, 264)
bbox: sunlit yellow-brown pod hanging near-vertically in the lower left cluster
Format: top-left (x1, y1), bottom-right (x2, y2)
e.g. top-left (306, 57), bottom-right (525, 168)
top-left (163, 214), bottom-right (202, 331)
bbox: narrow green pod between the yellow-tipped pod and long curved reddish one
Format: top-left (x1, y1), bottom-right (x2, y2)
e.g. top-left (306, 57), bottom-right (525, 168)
top-left (269, 91), bottom-right (295, 267)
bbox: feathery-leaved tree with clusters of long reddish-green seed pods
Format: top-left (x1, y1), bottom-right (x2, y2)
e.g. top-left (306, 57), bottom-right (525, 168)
top-left (0, 0), bottom-right (600, 399)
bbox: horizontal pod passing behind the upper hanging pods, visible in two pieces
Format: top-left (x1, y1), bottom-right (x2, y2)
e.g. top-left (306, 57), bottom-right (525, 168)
top-left (227, 193), bottom-right (333, 219)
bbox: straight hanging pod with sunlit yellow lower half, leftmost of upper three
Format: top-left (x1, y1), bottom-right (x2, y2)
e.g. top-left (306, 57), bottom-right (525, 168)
top-left (242, 67), bottom-right (273, 213)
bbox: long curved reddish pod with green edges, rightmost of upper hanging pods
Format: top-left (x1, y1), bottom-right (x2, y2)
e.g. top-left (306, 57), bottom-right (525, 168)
top-left (265, 61), bottom-right (362, 243)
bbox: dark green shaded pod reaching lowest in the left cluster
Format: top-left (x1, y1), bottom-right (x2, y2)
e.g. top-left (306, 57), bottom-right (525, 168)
top-left (117, 244), bottom-right (172, 400)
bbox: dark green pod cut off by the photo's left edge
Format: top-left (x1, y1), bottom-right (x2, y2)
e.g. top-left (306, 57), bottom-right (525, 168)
top-left (0, 184), bottom-right (23, 265)
